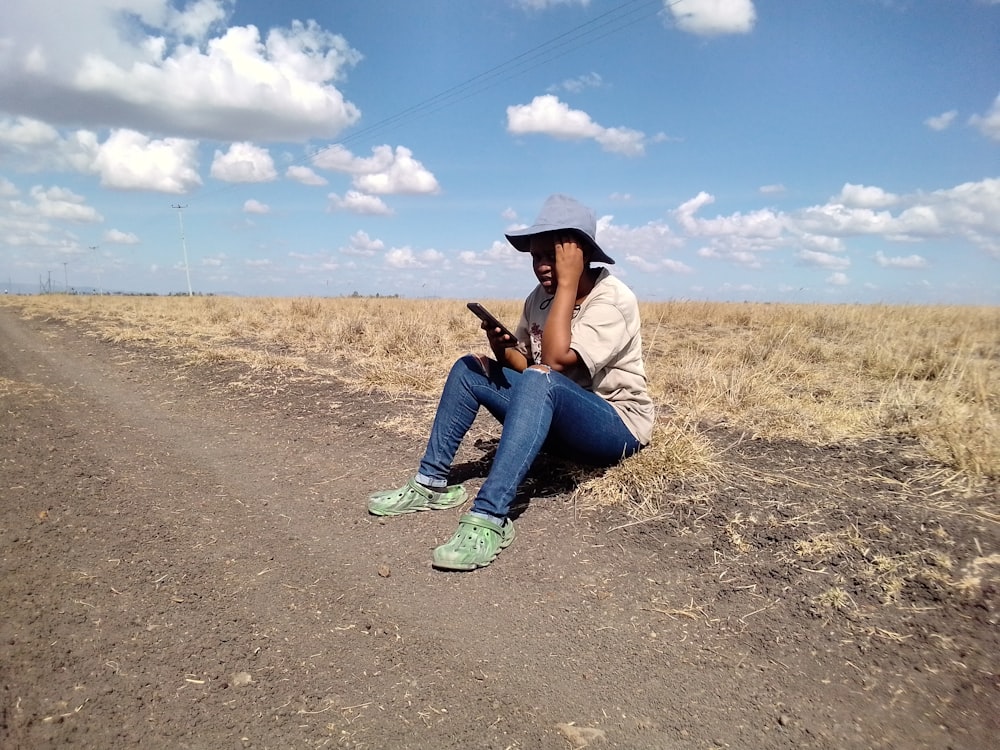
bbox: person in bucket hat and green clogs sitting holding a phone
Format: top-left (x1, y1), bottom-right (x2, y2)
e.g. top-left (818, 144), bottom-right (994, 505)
top-left (368, 195), bottom-right (653, 570)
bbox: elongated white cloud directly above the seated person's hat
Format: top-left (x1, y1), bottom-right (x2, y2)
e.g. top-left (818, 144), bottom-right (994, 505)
top-left (507, 94), bottom-right (646, 156)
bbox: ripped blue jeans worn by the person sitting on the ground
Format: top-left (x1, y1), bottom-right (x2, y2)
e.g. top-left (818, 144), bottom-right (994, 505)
top-left (417, 354), bottom-right (642, 518)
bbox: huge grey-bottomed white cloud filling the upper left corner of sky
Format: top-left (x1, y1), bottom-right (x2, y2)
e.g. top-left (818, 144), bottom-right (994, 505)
top-left (0, 0), bottom-right (361, 141)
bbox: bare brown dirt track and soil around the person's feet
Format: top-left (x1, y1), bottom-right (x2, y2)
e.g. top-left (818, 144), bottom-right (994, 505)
top-left (0, 311), bottom-right (1000, 750)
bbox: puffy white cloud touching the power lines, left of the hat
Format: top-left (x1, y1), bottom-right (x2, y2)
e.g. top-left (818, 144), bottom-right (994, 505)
top-left (312, 144), bottom-right (441, 195)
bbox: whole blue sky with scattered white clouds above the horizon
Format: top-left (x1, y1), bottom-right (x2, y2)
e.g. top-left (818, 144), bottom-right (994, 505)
top-left (0, 0), bottom-right (1000, 305)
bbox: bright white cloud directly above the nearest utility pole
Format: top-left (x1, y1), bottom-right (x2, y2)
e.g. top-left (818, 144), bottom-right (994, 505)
top-left (93, 130), bottom-right (201, 194)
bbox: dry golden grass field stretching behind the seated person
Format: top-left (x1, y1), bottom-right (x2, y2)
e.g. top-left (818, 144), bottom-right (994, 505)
top-left (0, 294), bottom-right (1000, 508)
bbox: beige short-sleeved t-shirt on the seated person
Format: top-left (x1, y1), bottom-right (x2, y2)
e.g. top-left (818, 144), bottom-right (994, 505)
top-left (515, 268), bottom-right (654, 445)
